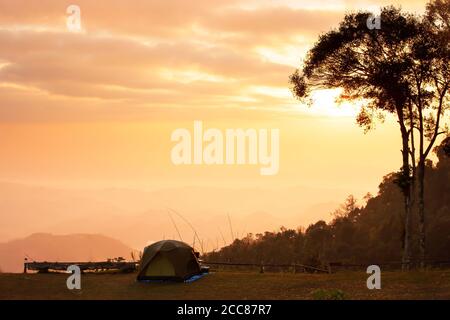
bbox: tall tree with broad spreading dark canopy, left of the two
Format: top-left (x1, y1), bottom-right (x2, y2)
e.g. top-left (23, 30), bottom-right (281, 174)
top-left (290, 7), bottom-right (420, 267)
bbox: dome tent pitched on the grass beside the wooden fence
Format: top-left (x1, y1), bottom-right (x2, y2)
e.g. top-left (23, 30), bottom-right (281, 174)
top-left (137, 240), bottom-right (201, 281)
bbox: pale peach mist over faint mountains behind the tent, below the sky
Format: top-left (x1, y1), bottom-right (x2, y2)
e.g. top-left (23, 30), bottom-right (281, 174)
top-left (0, 182), bottom-right (346, 250)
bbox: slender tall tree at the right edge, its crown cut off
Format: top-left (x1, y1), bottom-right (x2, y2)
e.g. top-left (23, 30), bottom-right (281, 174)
top-left (409, 0), bottom-right (450, 267)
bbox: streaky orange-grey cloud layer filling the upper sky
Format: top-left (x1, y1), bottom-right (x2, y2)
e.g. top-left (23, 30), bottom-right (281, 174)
top-left (0, 0), bottom-right (428, 121)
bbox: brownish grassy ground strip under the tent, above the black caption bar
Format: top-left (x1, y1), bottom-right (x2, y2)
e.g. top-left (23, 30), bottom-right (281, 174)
top-left (0, 270), bottom-right (450, 300)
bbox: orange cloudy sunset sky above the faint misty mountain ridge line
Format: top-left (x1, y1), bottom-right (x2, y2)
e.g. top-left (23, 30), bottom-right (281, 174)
top-left (0, 0), bottom-right (432, 242)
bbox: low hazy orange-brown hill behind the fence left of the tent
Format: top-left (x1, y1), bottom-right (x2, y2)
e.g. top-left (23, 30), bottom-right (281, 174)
top-left (0, 233), bottom-right (134, 272)
